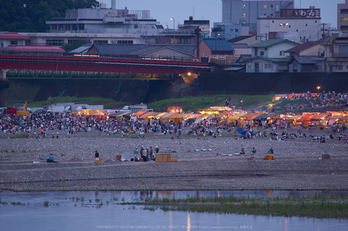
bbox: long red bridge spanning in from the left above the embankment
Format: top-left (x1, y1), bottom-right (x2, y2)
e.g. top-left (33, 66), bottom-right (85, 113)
top-left (0, 54), bottom-right (211, 74)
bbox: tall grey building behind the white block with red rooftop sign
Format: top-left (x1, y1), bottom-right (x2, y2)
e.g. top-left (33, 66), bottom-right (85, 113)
top-left (222, 0), bottom-right (294, 31)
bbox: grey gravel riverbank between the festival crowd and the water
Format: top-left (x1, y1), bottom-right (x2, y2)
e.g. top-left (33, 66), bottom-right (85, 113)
top-left (0, 131), bottom-right (348, 191)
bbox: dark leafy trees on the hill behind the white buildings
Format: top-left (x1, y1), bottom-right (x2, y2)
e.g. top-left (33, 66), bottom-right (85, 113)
top-left (0, 0), bottom-right (99, 32)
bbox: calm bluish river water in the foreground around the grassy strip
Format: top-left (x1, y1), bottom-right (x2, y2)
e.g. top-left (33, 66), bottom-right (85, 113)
top-left (0, 191), bottom-right (348, 231)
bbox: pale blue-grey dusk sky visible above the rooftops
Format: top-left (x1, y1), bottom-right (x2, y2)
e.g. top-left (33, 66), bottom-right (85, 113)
top-left (98, 0), bottom-right (345, 29)
